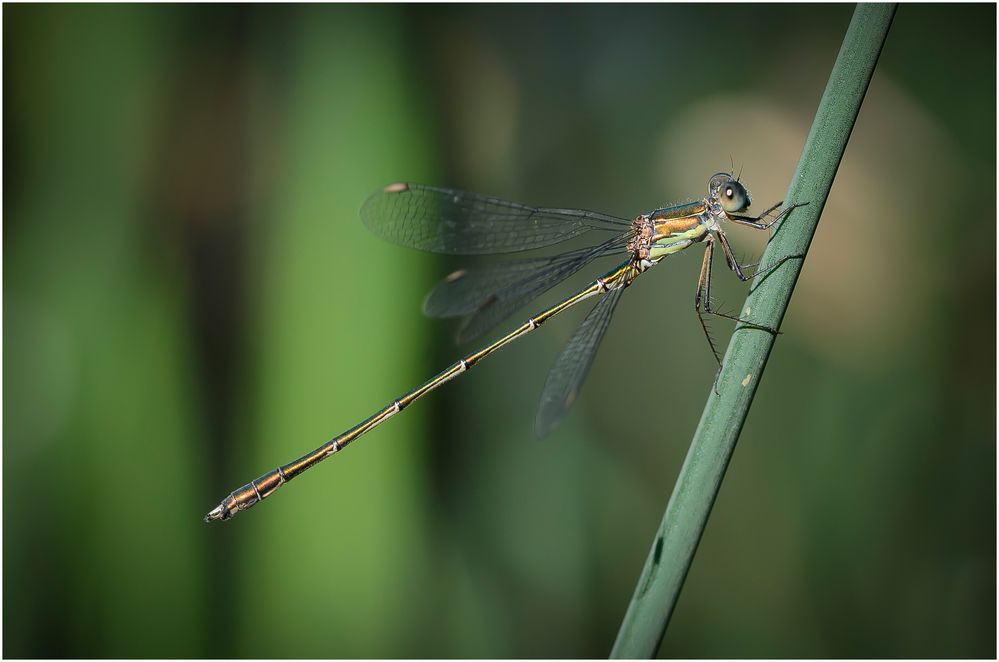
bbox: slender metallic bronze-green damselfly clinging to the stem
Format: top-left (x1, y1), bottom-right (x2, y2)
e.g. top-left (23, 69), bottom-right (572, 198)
top-left (205, 173), bottom-right (795, 521)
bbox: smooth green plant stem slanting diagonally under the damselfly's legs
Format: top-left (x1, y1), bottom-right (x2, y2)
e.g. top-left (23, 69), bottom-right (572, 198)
top-left (611, 4), bottom-right (895, 658)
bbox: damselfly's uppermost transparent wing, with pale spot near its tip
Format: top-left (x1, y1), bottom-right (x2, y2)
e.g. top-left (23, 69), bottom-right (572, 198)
top-left (361, 184), bottom-right (631, 255)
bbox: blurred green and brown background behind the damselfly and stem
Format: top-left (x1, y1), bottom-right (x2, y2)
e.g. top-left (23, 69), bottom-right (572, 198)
top-left (3, 5), bottom-right (996, 657)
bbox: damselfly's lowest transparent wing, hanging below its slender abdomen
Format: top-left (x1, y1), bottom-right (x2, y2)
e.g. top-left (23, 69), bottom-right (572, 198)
top-left (534, 288), bottom-right (624, 437)
